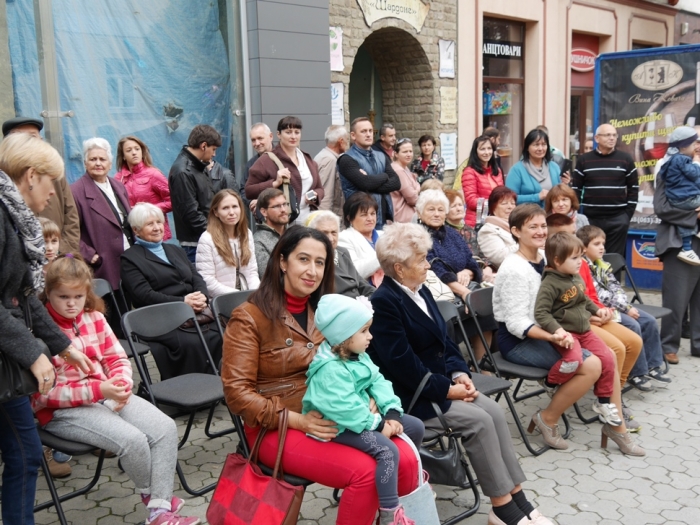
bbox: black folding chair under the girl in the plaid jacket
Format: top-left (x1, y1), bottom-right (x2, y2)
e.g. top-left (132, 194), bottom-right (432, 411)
top-left (34, 427), bottom-right (105, 525)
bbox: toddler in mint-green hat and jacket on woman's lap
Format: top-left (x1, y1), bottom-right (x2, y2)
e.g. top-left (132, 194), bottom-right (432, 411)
top-left (302, 294), bottom-right (425, 525)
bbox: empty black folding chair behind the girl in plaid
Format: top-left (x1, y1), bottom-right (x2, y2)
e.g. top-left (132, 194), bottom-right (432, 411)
top-left (122, 302), bottom-right (230, 496)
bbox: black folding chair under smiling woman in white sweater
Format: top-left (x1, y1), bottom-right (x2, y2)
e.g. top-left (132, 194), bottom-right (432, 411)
top-left (467, 288), bottom-right (598, 456)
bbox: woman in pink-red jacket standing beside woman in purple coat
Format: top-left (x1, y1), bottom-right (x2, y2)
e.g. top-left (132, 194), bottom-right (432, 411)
top-left (114, 135), bottom-right (173, 241)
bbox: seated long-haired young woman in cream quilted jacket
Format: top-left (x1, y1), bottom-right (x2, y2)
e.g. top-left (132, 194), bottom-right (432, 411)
top-left (196, 189), bottom-right (260, 297)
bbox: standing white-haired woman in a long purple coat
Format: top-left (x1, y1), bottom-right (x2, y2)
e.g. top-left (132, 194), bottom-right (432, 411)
top-left (70, 137), bottom-right (133, 290)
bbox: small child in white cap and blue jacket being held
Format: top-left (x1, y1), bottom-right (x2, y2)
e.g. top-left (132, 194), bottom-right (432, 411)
top-left (657, 126), bottom-right (700, 266)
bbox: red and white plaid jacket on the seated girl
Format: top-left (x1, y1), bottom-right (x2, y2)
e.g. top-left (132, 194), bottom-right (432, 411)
top-left (31, 309), bottom-right (134, 427)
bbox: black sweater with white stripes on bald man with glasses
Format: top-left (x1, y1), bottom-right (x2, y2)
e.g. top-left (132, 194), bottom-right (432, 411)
top-left (571, 150), bottom-right (639, 218)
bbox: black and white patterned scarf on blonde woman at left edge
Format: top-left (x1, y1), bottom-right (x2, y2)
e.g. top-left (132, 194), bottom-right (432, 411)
top-left (0, 170), bottom-right (47, 296)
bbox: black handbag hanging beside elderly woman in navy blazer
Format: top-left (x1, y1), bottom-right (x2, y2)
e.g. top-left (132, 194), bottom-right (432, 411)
top-left (406, 372), bottom-right (469, 487)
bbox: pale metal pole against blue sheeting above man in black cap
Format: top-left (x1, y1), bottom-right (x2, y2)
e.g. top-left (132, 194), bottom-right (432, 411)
top-left (34, 0), bottom-right (66, 156)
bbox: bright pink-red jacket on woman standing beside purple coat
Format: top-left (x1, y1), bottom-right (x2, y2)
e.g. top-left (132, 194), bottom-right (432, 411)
top-left (114, 162), bottom-right (173, 241)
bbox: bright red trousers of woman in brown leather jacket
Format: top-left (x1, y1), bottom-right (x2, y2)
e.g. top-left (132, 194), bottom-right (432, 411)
top-left (245, 425), bottom-right (418, 525)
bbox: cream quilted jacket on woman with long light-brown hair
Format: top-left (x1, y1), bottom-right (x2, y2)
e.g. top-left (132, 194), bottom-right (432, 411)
top-left (196, 230), bottom-right (260, 297)
